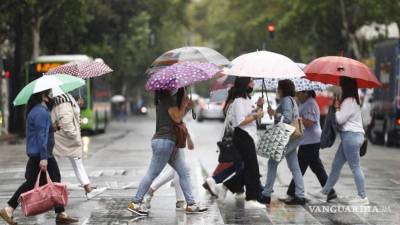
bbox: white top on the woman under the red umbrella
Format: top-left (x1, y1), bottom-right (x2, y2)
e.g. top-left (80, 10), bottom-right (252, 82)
top-left (336, 98), bottom-right (364, 133)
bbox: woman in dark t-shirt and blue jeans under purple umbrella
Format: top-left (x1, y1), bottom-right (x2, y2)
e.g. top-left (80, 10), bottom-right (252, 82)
top-left (128, 88), bottom-right (207, 216)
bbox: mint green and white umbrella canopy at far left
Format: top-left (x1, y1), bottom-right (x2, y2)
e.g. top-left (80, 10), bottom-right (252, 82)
top-left (13, 74), bottom-right (85, 106)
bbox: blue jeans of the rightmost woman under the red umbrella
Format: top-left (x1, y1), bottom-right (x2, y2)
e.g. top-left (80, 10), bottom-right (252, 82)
top-left (322, 131), bottom-right (366, 198)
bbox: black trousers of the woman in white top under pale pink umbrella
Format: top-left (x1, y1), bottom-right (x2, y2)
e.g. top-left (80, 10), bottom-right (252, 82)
top-left (224, 127), bottom-right (261, 200)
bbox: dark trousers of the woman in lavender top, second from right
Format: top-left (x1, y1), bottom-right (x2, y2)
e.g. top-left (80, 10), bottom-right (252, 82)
top-left (287, 143), bottom-right (335, 196)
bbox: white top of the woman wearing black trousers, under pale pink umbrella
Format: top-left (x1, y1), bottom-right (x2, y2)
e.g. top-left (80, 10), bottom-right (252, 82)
top-left (231, 98), bottom-right (257, 143)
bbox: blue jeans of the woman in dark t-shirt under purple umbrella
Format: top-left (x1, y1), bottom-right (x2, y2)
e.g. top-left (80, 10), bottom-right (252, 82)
top-left (133, 139), bottom-right (195, 205)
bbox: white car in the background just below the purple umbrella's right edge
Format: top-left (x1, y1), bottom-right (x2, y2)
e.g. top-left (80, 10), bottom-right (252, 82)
top-left (197, 98), bottom-right (225, 122)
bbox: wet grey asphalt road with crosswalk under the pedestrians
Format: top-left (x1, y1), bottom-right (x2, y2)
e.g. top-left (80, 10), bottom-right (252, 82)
top-left (0, 116), bottom-right (400, 225)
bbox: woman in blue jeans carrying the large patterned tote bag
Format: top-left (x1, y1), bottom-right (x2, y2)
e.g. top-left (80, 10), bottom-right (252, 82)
top-left (261, 80), bottom-right (306, 205)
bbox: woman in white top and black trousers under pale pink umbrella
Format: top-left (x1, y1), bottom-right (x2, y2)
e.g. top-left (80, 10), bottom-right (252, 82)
top-left (217, 77), bottom-right (264, 201)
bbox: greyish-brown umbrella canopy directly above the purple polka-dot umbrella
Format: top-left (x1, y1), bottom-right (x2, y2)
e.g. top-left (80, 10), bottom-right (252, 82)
top-left (146, 46), bottom-right (230, 74)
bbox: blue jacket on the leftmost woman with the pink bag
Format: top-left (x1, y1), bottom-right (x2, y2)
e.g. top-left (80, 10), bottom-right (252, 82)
top-left (26, 104), bottom-right (54, 159)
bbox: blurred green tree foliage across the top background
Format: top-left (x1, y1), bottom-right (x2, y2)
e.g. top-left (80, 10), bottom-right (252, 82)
top-left (0, 0), bottom-right (400, 98)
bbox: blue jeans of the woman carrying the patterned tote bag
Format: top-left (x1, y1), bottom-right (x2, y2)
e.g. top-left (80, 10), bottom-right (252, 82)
top-left (262, 140), bottom-right (304, 198)
